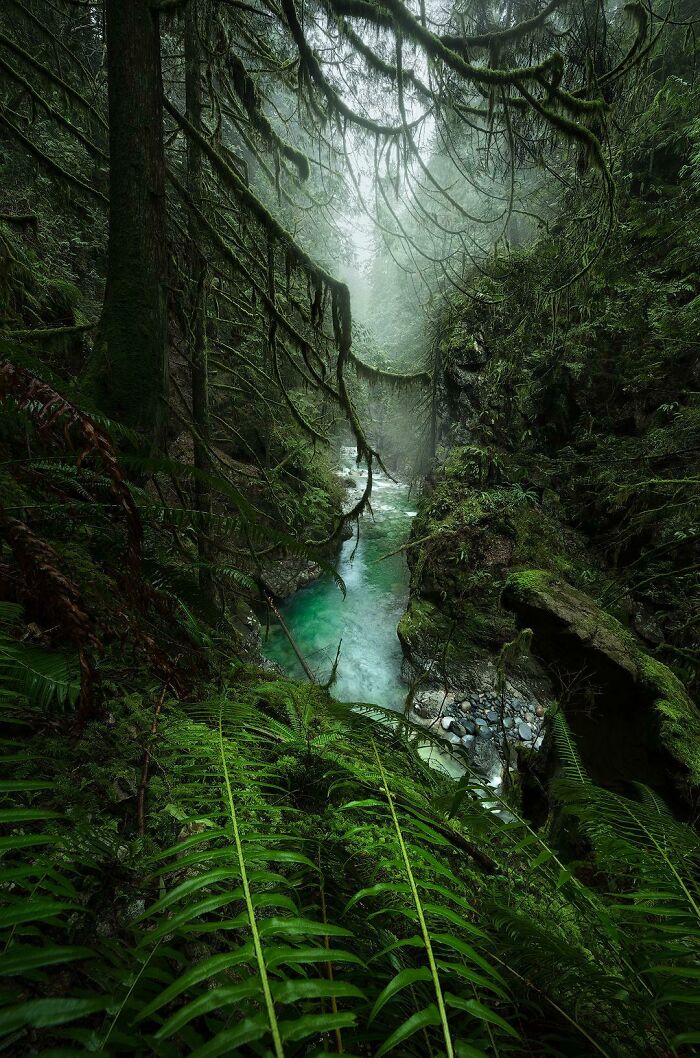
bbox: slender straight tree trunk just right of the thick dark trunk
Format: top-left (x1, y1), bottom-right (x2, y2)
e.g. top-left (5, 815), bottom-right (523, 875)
top-left (185, 0), bottom-right (214, 602)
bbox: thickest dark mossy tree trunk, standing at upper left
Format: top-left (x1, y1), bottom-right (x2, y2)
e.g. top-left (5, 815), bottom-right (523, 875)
top-left (97, 0), bottom-right (168, 446)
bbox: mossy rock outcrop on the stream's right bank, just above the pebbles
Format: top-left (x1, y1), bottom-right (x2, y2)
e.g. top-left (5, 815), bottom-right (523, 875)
top-left (399, 445), bottom-right (603, 657)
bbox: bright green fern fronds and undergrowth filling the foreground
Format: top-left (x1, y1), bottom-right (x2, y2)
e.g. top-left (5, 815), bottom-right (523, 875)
top-left (0, 647), bottom-right (698, 1055)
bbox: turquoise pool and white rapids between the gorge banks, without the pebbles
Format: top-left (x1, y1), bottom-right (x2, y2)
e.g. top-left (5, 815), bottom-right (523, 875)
top-left (264, 449), bottom-right (417, 709)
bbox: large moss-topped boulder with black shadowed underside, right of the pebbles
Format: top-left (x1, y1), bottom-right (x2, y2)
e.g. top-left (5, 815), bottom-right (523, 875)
top-left (502, 569), bottom-right (700, 795)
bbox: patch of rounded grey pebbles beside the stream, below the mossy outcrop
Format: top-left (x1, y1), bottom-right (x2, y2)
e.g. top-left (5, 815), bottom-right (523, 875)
top-left (408, 658), bottom-right (551, 786)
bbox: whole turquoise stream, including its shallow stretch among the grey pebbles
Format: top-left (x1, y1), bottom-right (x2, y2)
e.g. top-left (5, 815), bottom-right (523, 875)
top-left (263, 448), bottom-right (535, 799)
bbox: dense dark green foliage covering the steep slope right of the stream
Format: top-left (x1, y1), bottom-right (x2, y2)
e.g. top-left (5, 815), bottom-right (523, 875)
top-left (416, 77), bottom-right (700, 688)
